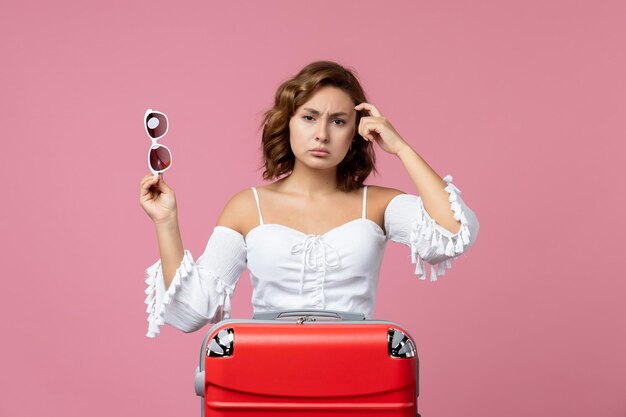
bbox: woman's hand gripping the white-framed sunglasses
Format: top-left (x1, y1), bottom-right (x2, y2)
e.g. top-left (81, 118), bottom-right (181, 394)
top-left (139, 174), bottom-right (176, 224)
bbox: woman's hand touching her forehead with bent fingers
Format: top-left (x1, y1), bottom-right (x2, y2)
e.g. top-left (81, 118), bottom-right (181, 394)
top-left (354, 103), bottom-right (409, 155)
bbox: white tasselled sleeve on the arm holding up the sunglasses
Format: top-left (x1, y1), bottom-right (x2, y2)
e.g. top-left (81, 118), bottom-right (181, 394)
top-left (145, 226), bottom-right (246, 337)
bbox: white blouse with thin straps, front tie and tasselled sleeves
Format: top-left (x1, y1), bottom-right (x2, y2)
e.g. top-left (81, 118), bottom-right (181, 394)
top-left (145, 175), bottom-right (479, 337)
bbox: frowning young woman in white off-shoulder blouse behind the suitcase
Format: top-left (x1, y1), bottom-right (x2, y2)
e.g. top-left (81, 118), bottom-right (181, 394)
top-left (140, 61), bottom-right (478, 337)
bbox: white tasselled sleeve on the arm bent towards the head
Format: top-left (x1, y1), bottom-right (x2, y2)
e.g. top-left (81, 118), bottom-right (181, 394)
top-left (385, 175), bottom-right (479, 281)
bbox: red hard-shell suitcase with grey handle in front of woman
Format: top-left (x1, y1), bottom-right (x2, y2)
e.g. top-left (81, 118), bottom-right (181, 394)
top-left (195, 310), bottom-right (419, 417)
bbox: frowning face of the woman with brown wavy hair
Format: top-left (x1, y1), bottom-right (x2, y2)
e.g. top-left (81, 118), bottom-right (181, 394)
top-left (289, 86), bottom-right (356, 169)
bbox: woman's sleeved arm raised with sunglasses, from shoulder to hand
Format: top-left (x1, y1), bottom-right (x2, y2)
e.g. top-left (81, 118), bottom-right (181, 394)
top-left (140, 179), bottom-right (246, 337)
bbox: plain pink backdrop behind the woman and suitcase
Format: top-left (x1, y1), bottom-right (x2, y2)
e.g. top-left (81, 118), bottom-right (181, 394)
top-left (0, 0), bottom-right (626, 417)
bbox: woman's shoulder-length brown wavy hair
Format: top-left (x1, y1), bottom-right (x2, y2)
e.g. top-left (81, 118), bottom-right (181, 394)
top-left (261, 61), bottom-right (377, 191)
